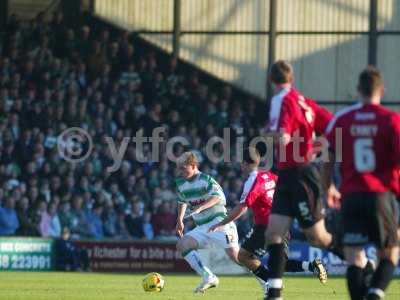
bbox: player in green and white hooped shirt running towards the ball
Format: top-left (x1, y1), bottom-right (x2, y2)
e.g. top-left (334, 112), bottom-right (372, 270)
top-left (176, 152), bottom-right (239, 293)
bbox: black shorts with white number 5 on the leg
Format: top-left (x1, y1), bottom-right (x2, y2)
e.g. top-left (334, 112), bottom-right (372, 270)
top-left (272, 164), bottom-right (324, 228)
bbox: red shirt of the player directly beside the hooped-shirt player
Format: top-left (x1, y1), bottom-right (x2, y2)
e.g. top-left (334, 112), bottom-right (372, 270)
top-left (240, 171), bottom-right (277, 225)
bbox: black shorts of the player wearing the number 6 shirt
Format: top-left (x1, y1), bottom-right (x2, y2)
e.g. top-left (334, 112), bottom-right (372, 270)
top-left (341, 192), bottom-right (399, 249)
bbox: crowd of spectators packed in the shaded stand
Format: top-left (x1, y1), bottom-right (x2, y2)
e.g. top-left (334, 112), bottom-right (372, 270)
top-left (0, 13), bottom-right (265, 239)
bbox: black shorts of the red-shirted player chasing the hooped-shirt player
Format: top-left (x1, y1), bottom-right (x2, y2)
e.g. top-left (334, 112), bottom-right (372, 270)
top-left (241, 225), bottom-right (289, 257)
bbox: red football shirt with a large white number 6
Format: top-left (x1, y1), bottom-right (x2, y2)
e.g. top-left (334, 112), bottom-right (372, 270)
top-left (327, 103), bottom-right (400, 194)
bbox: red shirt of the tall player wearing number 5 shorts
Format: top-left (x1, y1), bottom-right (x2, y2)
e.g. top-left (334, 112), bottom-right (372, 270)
top-left (269, 88), bottom-right (332, 169)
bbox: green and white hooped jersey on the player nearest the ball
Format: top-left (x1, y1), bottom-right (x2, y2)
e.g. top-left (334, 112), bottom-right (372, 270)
top-left (175, 172), bottom-right (226, 225)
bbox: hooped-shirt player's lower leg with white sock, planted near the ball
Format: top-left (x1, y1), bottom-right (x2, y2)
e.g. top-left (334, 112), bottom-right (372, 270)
top-left (177, 236), bottom-right (219, 293)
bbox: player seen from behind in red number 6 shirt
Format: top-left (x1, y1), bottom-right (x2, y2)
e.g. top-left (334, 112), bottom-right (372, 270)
top-left (324, 67), bottom-right (400, 300)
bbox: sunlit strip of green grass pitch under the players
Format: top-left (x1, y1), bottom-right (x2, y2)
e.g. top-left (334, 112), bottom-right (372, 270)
top-left (0, 272), bottom-right (400, 300)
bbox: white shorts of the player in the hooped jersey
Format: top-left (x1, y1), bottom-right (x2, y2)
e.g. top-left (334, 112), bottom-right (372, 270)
top-left (185, 217), bottom-right (239, 249)
